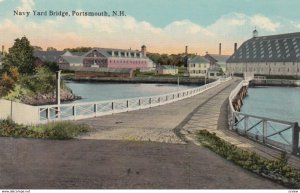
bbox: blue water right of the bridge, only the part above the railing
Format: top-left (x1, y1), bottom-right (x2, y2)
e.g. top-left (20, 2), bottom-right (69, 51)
top-left (241, 87), bottom-right (300, 122)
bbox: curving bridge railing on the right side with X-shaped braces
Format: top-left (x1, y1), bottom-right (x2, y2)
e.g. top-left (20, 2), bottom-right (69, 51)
top-left (228, 80), bottom-right (300, 155)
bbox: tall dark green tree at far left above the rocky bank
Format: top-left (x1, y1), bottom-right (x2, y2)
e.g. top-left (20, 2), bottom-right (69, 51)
top-left (3, 37), bottom-right (35, 74)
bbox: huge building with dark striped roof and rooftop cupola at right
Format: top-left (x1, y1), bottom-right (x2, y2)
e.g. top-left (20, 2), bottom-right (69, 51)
top-left (226, 30), bottom-right (300, 76)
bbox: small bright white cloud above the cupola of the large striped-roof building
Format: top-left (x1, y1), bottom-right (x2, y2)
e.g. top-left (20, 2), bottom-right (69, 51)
top-left (251, 15), bottom-right (280, 32)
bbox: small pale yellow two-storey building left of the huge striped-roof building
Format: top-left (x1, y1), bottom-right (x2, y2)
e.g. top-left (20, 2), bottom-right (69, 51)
top-left (187, 56), bottom-right (210, 77)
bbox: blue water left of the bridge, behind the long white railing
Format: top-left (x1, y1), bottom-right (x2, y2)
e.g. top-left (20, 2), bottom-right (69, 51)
top-left (66, 82), bottom-right (196, 102)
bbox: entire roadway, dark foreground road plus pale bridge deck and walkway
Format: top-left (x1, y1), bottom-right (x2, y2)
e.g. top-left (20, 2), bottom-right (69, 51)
top-left (0, 80), bottom-right (283, 189)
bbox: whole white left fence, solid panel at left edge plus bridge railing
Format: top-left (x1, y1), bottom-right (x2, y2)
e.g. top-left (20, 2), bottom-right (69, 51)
top-left (0, 77), bottom-right (231, 124)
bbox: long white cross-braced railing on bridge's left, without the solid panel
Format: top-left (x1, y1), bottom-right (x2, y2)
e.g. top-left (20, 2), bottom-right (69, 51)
top-left (38, 77), bottom-right (231, 123)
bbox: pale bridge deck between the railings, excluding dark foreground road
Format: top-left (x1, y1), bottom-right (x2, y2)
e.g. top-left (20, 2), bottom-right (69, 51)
top-left (78, 79), bottom-right (241, 143)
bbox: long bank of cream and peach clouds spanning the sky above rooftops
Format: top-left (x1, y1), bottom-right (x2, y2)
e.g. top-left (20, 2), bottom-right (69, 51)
top-left (0, 6), bottom-right (300, 54)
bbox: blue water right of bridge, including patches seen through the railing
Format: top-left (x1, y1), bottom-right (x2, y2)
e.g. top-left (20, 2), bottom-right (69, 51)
top-left (239, 87), bottom-right (300, 149)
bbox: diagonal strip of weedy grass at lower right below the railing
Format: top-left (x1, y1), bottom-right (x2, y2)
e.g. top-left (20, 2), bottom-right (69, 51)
top-left (197, 130), bottom-right (300, 188)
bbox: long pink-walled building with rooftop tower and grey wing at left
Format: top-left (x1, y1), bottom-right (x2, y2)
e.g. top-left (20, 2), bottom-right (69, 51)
top-left (58, 45), bottom-right (153, 70)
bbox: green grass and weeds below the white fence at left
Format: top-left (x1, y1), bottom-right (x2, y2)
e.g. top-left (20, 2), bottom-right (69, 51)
top-left (0, 120), bottom-right (90, 140)
